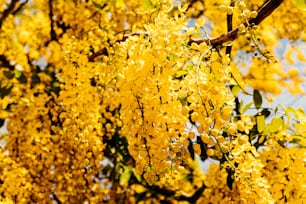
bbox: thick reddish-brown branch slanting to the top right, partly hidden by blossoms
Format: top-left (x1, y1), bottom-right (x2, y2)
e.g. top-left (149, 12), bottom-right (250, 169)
top-left (88, 0), bottom-right (284, 62)
